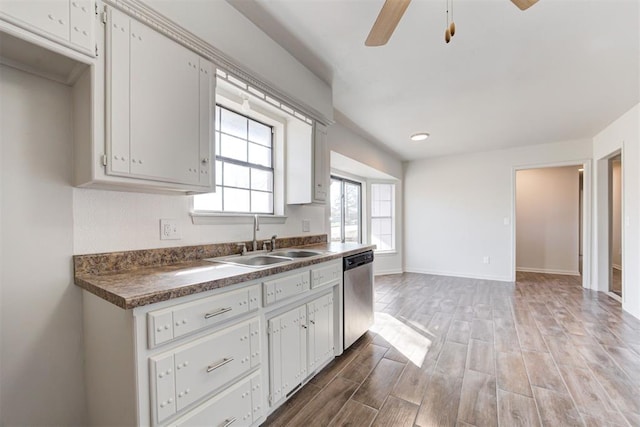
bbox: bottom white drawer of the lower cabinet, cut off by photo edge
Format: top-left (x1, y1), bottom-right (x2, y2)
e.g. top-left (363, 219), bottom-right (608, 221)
top-left (170, 373), bottom-right (262, 427)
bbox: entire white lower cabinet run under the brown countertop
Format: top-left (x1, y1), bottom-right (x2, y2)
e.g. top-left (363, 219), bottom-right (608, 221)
top-left (83, 260), bottom-right (342, 427)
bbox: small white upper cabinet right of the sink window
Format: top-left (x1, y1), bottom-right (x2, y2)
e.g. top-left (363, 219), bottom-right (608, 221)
top-left (287, 122), bottom-right (329, 205)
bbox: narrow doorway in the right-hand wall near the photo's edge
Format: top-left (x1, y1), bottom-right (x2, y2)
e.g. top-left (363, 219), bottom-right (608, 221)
top-left (608, 154), bottom-right (623, 299)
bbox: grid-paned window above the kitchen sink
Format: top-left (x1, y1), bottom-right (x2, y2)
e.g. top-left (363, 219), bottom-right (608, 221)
top-left (194, 105), bottom-right (274, 214)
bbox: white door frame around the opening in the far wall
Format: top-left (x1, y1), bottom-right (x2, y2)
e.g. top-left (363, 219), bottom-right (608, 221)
top-left (510, 159), bottom-right (593, 289)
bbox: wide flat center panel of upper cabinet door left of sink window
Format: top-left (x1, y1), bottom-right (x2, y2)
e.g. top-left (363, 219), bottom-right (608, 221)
top-left (129, 20), bottom-right (200, 184)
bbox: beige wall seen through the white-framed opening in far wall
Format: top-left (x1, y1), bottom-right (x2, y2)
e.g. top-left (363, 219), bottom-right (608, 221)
top-left (516, 166), bottom-right (580, 275)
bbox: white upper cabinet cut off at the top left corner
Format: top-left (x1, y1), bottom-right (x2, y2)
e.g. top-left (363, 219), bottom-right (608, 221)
top-left (0, 0), bottom-right (96, 56)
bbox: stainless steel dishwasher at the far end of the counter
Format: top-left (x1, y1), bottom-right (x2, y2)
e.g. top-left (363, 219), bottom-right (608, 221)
top-left (343, 251), bottom-right (373, 349)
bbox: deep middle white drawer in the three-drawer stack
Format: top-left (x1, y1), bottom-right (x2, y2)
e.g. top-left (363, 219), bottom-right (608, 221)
top-left (150, 318), bottom-right (261, 421)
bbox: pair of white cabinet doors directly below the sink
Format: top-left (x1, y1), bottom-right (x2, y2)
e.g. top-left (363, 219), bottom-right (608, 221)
top-left (267, 293), bottom-right (335, 406)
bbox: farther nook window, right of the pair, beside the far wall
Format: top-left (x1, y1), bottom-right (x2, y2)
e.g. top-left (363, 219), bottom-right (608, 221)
top-left (371, 184), bottom-right (395, 251)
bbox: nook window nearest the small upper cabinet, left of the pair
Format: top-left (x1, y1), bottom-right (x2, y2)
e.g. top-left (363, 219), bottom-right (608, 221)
top-left (330, 176), bottom-right (362, 243)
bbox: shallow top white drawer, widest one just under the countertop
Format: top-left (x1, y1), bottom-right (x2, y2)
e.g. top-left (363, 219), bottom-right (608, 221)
top-left (148, 285), bottom-right (260, 348)
